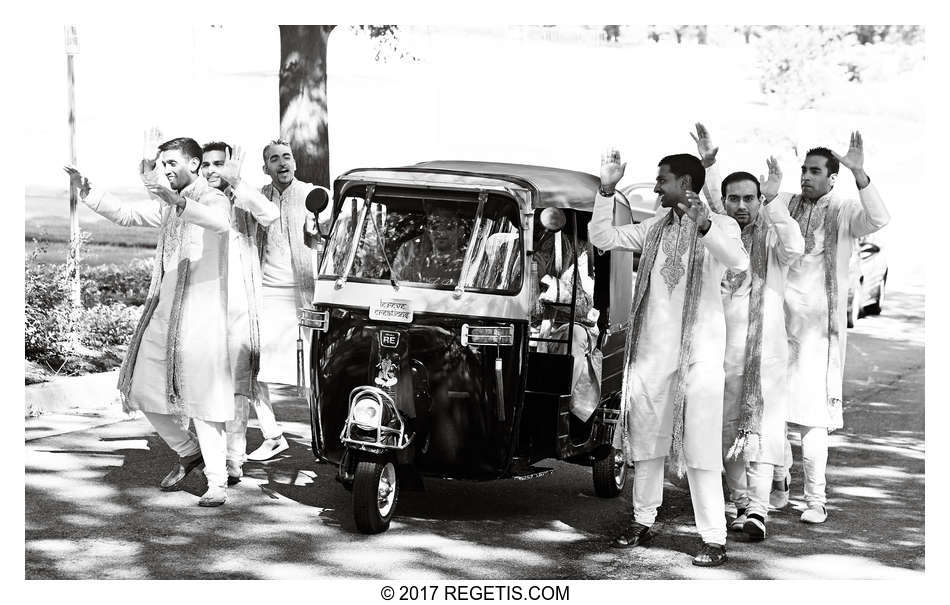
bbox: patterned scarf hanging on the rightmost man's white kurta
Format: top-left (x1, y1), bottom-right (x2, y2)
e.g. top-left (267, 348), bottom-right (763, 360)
top-left (788, 195), bottom-right (842, 420)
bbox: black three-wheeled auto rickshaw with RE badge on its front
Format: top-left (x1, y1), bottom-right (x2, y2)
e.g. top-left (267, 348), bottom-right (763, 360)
top-left (298, 161), bottom-right (645, 533)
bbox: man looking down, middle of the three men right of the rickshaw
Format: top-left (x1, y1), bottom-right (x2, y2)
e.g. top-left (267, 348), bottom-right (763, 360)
top-left (706, 158), bottom-right (805, 540)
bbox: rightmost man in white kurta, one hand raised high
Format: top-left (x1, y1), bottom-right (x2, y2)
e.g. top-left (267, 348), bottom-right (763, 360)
top-left (777, 132), bottom-right (890, 523)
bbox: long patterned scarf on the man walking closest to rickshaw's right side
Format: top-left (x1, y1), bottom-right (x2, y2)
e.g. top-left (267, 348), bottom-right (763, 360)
top-left (620, 210), bottom-right (706, 477)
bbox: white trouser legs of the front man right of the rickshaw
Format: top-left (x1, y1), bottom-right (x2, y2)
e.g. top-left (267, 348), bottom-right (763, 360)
top-left (633, 456), bottom-right (726, 544)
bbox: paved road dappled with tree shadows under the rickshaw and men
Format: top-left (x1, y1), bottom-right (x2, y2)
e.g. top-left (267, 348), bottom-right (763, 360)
top-left (26, 289), bottom-right (924, 580)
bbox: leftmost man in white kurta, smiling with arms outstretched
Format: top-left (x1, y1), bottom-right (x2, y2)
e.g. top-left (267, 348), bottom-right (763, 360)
top-left (66, 136), bottom-right (234, 506)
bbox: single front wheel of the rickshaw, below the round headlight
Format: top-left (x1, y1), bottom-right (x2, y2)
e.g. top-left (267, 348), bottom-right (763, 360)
top-left (353, 460), bottom-right (399, 534)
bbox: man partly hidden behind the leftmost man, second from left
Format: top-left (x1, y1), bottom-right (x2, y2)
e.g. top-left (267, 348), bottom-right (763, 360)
top-left (201, 141), bottom-right (280, 484)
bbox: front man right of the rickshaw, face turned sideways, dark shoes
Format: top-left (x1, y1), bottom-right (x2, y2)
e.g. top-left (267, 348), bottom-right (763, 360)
top-left (589, 154), bottom-right (749, 566)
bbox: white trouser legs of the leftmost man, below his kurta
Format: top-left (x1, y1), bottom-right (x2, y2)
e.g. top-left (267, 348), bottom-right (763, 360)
top-left (144, 412), bottom-right (228, 487)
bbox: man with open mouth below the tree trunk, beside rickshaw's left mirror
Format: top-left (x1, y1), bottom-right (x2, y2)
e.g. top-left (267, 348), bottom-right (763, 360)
top-left (248, 140), bottom-right (315, 460)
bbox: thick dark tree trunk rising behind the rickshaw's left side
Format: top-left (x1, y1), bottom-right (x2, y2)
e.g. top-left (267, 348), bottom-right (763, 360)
top-left (279, 25), bottom-right (336, 187)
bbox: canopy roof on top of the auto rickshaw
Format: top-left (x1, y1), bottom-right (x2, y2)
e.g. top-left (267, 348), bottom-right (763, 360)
top-left (340, 160), bottom-right (600, 212)
